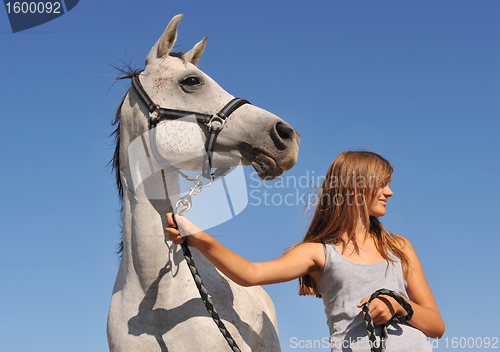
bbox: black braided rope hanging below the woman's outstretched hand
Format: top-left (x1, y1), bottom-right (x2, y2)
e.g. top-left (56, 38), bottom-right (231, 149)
top-left (173, 217), bottom-right (241, 352)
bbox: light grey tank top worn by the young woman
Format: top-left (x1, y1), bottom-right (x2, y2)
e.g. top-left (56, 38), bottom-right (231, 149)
top-left (316, 243), bottom-right (432, 352)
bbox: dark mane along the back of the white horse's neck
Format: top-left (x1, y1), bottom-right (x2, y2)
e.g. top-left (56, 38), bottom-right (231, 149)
top-left (108, 51), bottom-right (184, 255)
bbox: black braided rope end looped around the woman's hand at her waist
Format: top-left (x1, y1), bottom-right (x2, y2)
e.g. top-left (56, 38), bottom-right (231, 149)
top-left (361, 288), bottom-right (413, 352)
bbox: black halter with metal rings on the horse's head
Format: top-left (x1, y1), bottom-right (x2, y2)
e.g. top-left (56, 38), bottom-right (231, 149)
top-left (130, 71), bottom-right (250, 179)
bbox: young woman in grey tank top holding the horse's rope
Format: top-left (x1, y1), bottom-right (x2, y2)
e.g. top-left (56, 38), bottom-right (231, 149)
top-left (166, 152), bottom-right (445, 352)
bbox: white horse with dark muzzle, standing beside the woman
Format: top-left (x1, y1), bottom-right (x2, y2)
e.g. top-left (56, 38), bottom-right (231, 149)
top-left (107, 15), bottom-right (299, 352)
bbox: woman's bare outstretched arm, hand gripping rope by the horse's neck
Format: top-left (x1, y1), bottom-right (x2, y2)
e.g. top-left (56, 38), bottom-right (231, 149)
top-left (165, 213), bottom-right (324, 286)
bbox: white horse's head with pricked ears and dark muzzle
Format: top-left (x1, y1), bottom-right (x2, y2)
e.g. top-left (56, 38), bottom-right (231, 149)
top-left (122, 15), bottom-right (300, 179)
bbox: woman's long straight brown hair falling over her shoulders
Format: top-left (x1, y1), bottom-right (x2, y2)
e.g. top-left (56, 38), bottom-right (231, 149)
top-left (299, 151), bottom-right (410, 297)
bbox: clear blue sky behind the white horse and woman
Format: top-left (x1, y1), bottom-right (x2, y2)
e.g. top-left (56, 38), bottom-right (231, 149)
top-left (0, 0), bottom-right (500, 352)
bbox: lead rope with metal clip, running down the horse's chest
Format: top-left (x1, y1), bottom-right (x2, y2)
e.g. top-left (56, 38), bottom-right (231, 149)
top-left (161, 170), bottom-right (241, 352)
